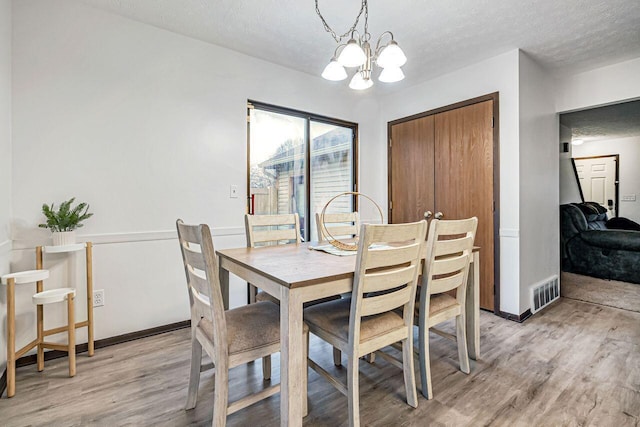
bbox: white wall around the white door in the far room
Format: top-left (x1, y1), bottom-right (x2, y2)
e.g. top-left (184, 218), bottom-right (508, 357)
top-left (573, 136), bottom-right (640, 222)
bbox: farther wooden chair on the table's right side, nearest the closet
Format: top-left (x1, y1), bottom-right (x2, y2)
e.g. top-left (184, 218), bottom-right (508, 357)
top-left (415, 217), bottom-right (478, 399)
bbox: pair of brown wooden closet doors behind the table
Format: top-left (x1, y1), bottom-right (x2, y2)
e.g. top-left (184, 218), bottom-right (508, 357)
top-left (389, 100), bottom-right (497, 310)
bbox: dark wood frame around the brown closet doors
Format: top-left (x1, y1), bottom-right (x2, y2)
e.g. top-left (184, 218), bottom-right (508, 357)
top-left (387, 92), bottom-right (500, 314)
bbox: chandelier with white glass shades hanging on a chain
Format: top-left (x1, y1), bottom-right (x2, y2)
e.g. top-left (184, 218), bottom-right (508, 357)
top-left (315, 0), bottom-right (407, 90)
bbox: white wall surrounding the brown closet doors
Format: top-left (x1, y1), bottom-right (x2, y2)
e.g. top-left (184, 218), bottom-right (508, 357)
top-left (380, 50), bottom-right (521, 314)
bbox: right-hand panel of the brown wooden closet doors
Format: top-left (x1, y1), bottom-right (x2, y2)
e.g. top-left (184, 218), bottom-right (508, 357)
top-left (435, 101), bottom-right (494, 310)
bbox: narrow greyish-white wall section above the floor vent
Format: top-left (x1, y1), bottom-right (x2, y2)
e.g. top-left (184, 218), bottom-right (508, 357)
top-left (518, 52), bottom-right (560, 313)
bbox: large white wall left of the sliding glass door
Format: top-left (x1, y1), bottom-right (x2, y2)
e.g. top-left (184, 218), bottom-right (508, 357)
top-left (12, 0), bottom-right (360, 352)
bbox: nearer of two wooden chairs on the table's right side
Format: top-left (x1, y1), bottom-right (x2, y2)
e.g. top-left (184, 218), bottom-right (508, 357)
top-left (304, 221), bottom-right (427, 426)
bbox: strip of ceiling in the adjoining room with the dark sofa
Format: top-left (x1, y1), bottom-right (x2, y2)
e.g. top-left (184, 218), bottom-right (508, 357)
top-left (560, 100), bottom-right (640, 141)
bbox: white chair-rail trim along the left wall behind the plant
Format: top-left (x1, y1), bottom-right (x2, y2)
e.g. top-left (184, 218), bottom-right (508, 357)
top-left (10, 227), bottom-right (245, 250)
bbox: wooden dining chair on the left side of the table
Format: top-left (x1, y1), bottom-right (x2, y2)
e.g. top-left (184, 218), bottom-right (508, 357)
top-left (176, 219), bottom-right (308, 426)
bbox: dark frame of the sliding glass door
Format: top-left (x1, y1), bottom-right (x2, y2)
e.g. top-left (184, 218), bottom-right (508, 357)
top-left (246, 99), bottom-right (359, 240)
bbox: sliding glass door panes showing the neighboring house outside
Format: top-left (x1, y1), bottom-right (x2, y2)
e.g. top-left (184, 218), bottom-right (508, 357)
top-left (248, 102), bottom-right (357, 241)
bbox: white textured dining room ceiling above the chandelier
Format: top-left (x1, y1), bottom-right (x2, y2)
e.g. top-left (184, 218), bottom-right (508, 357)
top-left (80, 0), bottom-right (640, 92)
